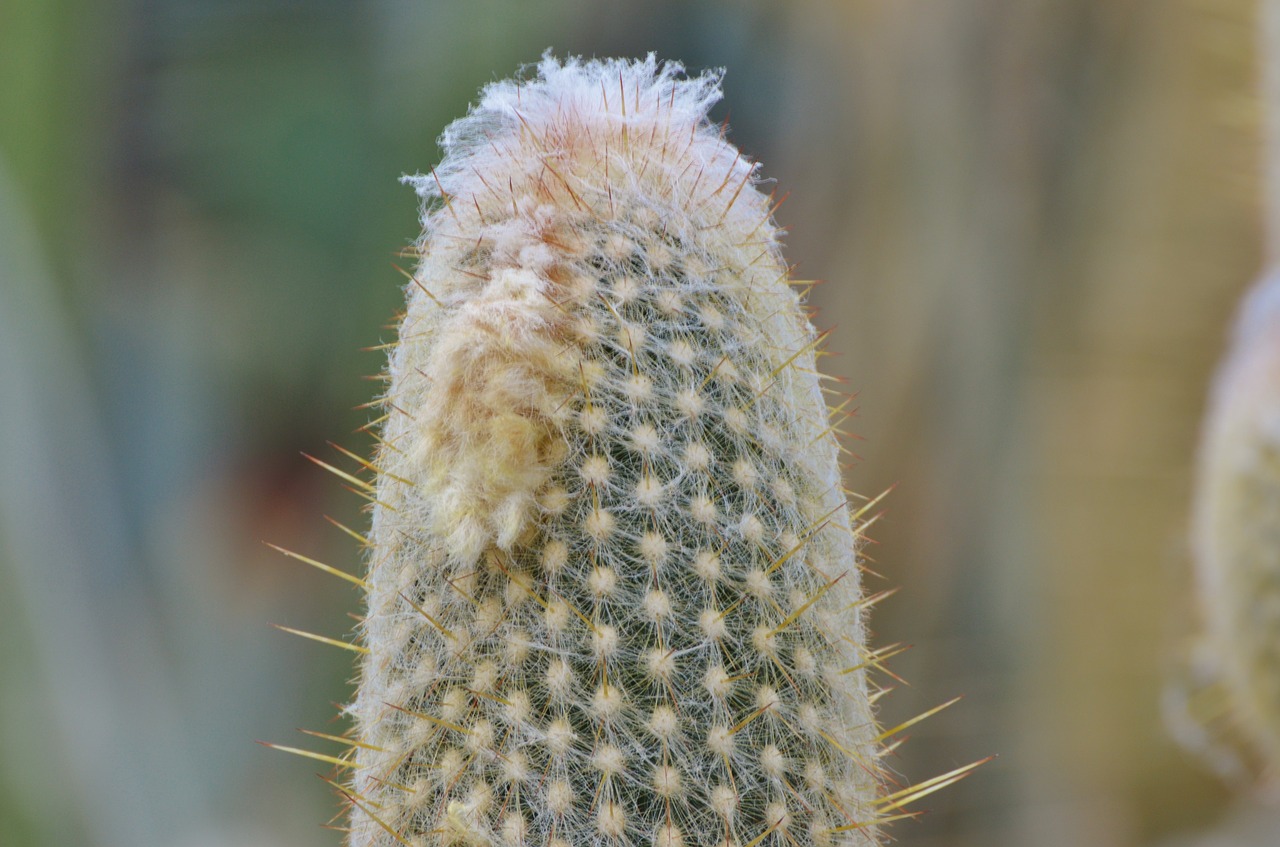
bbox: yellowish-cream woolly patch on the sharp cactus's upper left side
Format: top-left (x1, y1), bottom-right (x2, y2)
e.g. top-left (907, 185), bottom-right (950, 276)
top-left (404, 252), bottom-right (576, 563)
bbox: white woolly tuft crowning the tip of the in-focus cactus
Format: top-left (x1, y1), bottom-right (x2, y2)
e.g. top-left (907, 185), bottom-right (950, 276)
top-left (404, 54), bottom-right (762, 262)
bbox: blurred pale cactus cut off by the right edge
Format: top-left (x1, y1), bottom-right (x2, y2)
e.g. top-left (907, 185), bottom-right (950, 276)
top-left (1166, 0), bottom-right (1280, 789)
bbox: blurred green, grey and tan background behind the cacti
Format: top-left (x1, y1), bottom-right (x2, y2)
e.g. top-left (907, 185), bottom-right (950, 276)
top-left (0, 0), bottom-right (1264, 847)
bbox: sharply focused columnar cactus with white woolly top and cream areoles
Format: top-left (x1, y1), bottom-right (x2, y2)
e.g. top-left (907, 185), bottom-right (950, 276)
top-left (348, 58), bottom-right (881, 847)
